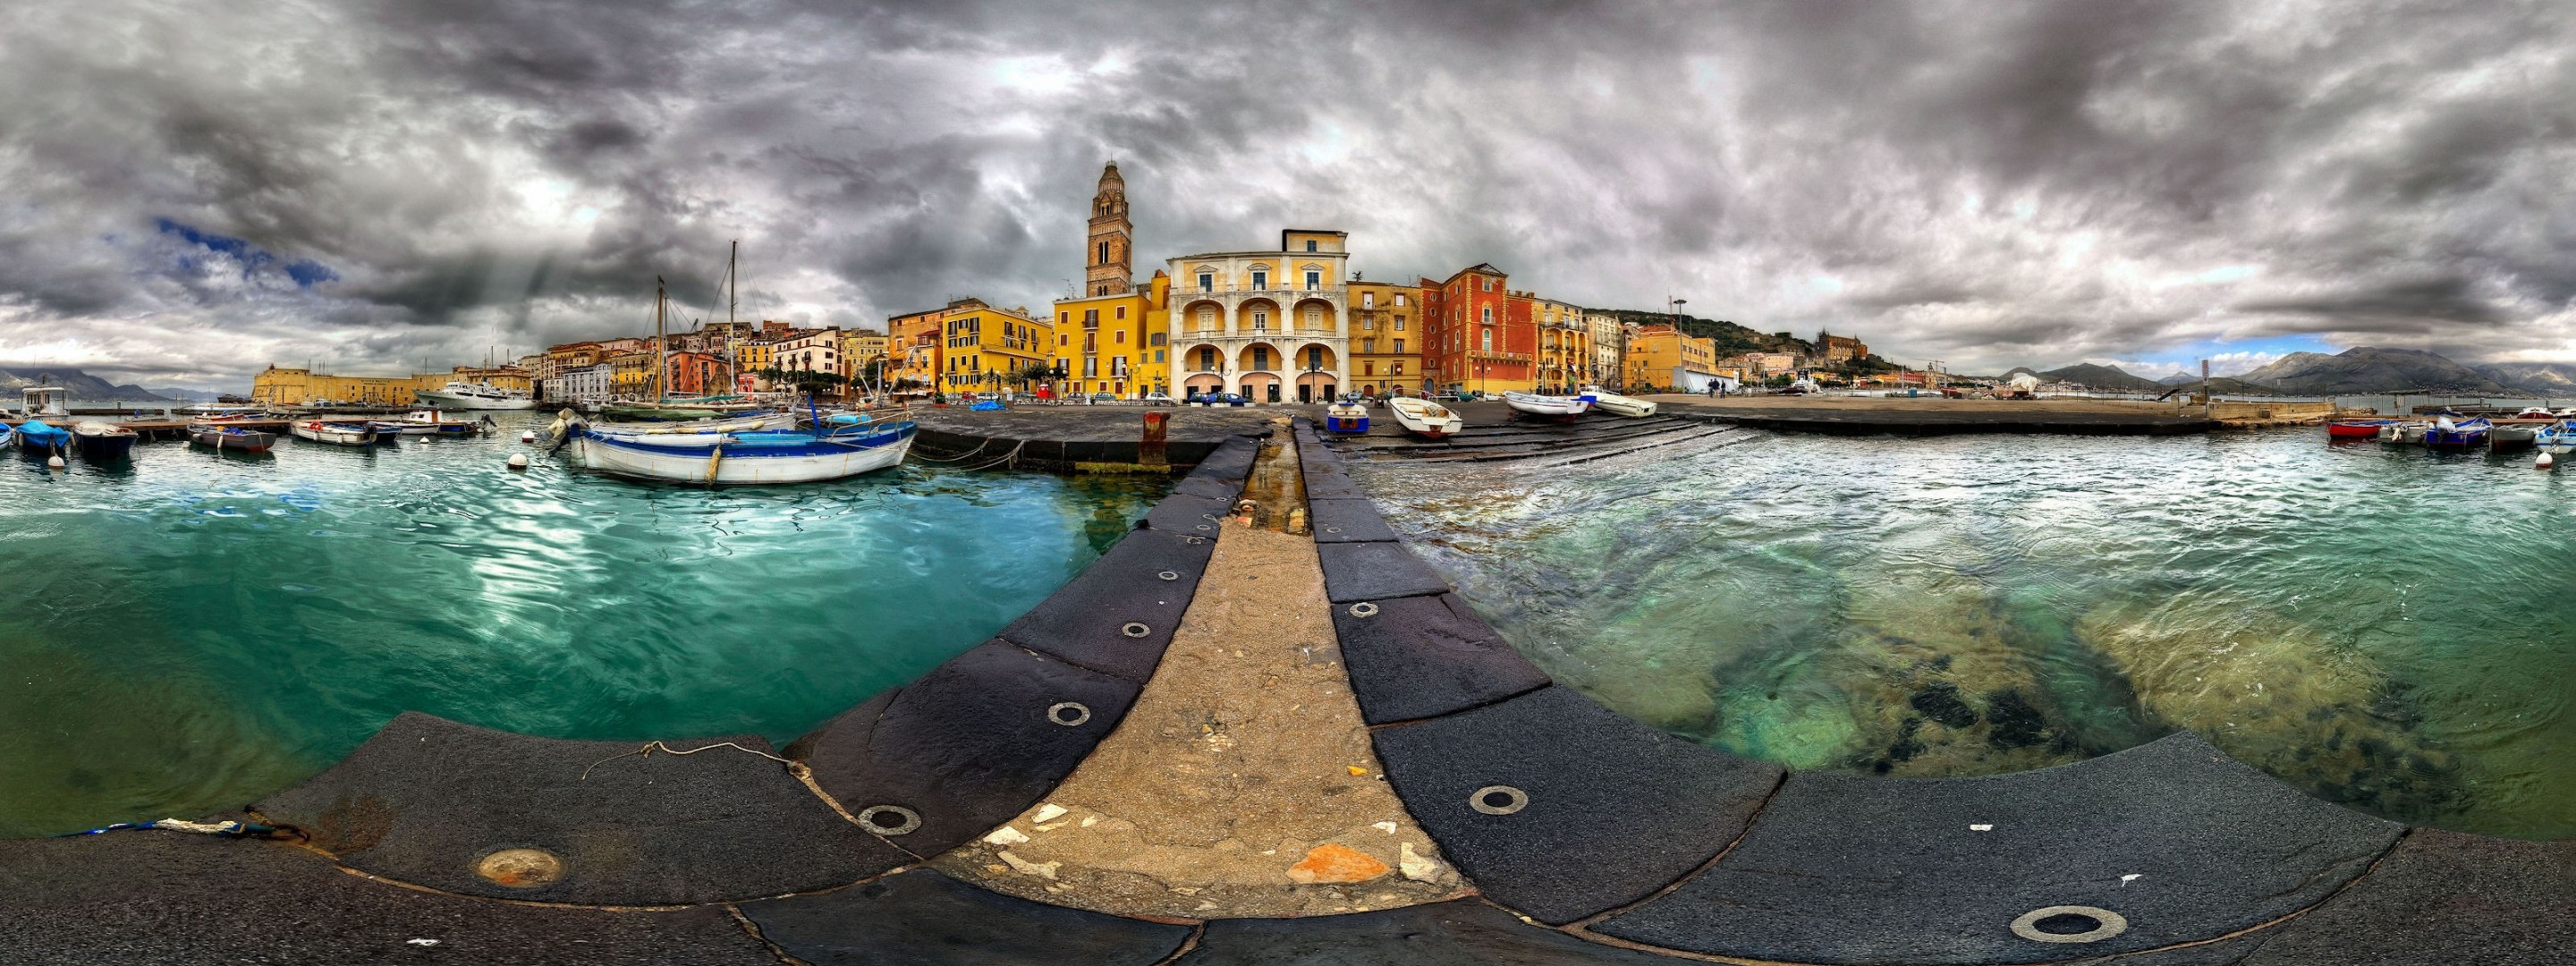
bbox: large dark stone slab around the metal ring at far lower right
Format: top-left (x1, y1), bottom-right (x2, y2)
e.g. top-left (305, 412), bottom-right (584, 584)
top-left (1595, 732), bottom-right (2398, 963)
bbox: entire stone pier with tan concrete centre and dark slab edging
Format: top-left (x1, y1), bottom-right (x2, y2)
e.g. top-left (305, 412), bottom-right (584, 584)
top-left (0, 425), bottom-right (2576, 966)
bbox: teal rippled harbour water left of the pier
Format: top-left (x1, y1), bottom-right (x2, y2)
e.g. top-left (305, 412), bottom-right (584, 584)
top-left (0, 415), bottom-right (1165, 837)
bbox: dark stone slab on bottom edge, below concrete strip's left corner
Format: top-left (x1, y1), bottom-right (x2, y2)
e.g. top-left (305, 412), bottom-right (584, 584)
top-left (741, 870), bottom-right (1191, 966)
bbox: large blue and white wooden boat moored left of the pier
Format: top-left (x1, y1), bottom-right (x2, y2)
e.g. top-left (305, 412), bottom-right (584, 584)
top-left (562, 419), bottom-right (917, 484)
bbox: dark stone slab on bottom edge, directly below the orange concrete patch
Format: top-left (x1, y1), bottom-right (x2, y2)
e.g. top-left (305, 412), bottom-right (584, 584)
top-left (1177, 899), bottom-right (1677, 966)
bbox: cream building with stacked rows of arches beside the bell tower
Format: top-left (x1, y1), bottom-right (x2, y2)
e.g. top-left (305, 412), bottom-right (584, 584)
top-left (1167, 229), bottom-right (1350, 402)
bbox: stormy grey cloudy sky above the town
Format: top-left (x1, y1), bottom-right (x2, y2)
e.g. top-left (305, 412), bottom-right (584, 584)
top-left (0, 0), bottom-right (2576, 386)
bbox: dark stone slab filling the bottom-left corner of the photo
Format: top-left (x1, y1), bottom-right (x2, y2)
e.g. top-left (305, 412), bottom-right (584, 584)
top-left (0, 835), bottom-right (778, 966)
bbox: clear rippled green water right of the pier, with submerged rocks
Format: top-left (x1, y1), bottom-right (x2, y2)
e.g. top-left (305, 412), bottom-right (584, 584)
top-left (1355, 430), bottom-right (2576, 837)
